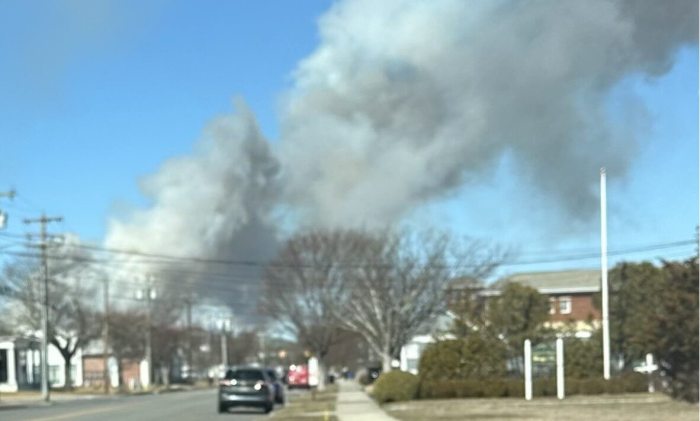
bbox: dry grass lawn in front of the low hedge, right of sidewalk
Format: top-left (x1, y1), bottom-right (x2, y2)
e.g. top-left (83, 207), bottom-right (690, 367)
top-left (382, 393), bottom-right (698, 421)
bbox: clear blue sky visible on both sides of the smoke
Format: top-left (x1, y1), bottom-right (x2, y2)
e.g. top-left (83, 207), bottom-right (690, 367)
top-left (0, 1), bottom-right (698, 272)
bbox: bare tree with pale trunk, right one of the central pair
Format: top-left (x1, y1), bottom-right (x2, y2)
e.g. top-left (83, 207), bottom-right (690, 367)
top-left (335, 231), bottom-right (505, 371)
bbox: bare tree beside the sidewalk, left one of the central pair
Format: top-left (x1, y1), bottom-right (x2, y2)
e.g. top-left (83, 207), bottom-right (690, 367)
top-left (261, 231), bottom-right (356, 389)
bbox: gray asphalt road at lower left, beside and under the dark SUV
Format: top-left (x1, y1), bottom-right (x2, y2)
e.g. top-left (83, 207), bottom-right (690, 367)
top-left (0, 389), bottom-right (284, 421)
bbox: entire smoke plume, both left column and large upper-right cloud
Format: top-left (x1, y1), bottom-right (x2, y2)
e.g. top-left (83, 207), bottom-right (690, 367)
top-left (107, 0), bottom-right (698, 312)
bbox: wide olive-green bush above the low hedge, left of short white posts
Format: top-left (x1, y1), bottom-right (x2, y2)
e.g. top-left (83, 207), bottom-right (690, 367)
top-left (419, 335), bottom-right (506, 381)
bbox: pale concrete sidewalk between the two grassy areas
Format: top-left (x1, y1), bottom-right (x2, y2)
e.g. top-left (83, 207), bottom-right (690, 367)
top-left (335, 380), bottom-right (396, 421)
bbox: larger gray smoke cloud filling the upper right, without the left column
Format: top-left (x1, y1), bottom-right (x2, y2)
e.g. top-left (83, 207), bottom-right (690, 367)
top-left (281, 0), bottom-right (698, 225)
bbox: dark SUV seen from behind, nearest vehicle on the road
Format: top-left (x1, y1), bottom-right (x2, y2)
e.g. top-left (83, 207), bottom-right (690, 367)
top-left (219, 367), bottom-right (275, 413)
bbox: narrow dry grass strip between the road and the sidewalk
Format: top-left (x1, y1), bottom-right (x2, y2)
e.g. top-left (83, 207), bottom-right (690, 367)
top-left (272, 385), bottom-right (338, 421)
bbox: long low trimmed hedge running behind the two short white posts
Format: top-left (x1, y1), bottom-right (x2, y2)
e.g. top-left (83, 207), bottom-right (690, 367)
top-left (418, 373), bottom-right (647, 399)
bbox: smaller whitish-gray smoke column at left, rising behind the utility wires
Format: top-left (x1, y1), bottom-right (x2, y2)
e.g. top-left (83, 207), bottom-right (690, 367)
top-left (105, 101), bottom-right (279, 313)
